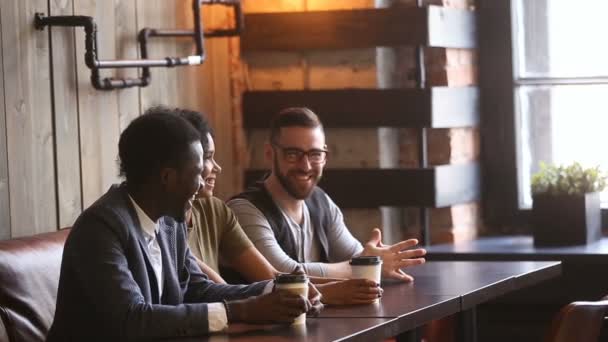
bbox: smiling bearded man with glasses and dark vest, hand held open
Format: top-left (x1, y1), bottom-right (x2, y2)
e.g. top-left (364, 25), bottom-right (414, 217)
top-left (228, 107), bottom-right (426, 282)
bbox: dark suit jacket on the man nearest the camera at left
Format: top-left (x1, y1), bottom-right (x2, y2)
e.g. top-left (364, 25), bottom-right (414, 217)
top-left (47, 184), bottom-right (267, 342)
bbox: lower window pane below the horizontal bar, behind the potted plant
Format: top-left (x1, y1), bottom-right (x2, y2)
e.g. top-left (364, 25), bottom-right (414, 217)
top-left (516, 84), bottom-right (608, 208)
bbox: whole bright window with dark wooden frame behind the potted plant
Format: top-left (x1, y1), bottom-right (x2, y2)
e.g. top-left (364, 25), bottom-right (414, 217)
top-left (477, 0), bottom-right (608, 230)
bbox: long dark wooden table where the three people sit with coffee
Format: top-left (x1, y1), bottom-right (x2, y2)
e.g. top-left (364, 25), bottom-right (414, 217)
top-left (162, 262), bottom-right (561, 341)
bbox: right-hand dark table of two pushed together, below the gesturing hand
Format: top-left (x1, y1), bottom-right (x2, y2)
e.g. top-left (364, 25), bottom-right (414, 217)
top-left (321, 261), bottom-right (561, 341)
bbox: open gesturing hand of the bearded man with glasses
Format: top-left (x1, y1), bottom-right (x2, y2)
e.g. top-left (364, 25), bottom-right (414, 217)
top-left (361, 228), bottom-right (426, 282)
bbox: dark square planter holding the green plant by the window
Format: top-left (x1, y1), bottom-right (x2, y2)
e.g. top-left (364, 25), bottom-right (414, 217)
top-left (532, 192), bottom-right (602, 246)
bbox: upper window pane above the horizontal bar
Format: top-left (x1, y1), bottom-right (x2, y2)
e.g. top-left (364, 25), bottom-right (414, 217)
top-left (513, 0), bottom-right (608, 78)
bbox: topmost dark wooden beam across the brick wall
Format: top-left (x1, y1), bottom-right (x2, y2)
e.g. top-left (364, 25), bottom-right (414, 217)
top-left (241, 6), bottom-right (476, 51)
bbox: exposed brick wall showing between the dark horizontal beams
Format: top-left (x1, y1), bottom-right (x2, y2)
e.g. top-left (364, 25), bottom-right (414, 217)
top-left (237, 0), bottom-right (480, 246)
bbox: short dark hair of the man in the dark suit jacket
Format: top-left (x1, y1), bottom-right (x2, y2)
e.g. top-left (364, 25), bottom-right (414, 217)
top-left (118, 106), bottom-right (201, 186)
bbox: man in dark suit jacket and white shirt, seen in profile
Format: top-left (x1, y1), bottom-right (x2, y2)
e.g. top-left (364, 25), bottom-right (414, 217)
top-left (47, 108), bottom-right (318, 342)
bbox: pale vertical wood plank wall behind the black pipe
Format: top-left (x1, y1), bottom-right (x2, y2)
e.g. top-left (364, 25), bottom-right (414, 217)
top-left (0, 0), bottom-right (218, 239)
